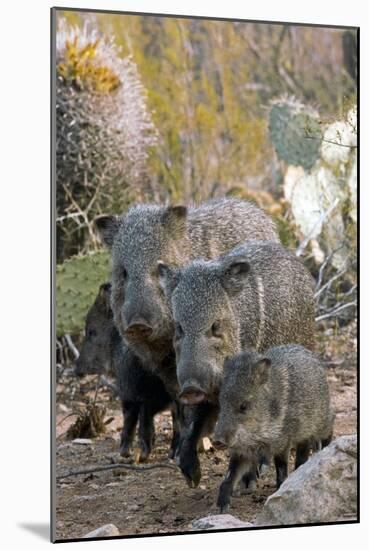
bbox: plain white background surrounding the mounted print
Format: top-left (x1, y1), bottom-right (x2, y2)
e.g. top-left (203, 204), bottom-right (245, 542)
top-left (0, 0), bottom-right (369, 550)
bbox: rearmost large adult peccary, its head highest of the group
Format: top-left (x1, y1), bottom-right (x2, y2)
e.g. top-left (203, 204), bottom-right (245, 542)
top-left (96, 199), bottom-right (278, 484)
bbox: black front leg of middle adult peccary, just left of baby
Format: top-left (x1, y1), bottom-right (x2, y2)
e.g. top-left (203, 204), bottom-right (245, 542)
top-left (176, 403), bottom-right (218, 487)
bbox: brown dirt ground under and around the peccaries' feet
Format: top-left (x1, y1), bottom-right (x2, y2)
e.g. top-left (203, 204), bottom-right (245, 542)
top-left (56, 324), bottom-right (357, 539)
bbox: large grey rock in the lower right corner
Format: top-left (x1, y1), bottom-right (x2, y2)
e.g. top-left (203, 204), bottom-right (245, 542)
top-left (255, 435), bottom-right (357, 526)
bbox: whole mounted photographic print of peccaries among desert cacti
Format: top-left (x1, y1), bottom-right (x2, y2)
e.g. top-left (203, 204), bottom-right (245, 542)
top-left (51, 8), bottom-right (359, 541)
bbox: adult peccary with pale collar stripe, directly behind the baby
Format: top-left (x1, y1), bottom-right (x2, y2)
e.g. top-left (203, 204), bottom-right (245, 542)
top-left (160, 241), bottom-right (314, 488)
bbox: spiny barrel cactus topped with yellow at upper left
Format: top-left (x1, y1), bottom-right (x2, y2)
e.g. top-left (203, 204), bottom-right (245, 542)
top-left (56, 18), bottom-right (158, 261)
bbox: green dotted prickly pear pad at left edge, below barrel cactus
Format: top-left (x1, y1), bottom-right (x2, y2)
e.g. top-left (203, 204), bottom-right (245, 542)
top-left (56, 250), bottom-right (110, 337)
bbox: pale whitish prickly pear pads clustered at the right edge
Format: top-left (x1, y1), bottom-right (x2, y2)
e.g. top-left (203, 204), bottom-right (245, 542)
top-left (283, 108), bottom-right (357, 269)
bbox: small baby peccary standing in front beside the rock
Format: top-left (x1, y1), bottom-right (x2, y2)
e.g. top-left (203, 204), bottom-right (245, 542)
top-left (213, 344), bottom-right (334, 512)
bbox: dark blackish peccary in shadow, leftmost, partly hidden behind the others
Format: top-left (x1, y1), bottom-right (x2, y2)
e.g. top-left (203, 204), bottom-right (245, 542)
top-left (75, 283), bottom-right (179, 462)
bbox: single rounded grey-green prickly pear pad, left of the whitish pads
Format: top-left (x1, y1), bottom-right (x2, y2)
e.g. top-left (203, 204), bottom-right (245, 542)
top-left (269, 99), bottom-right (322, 170)
